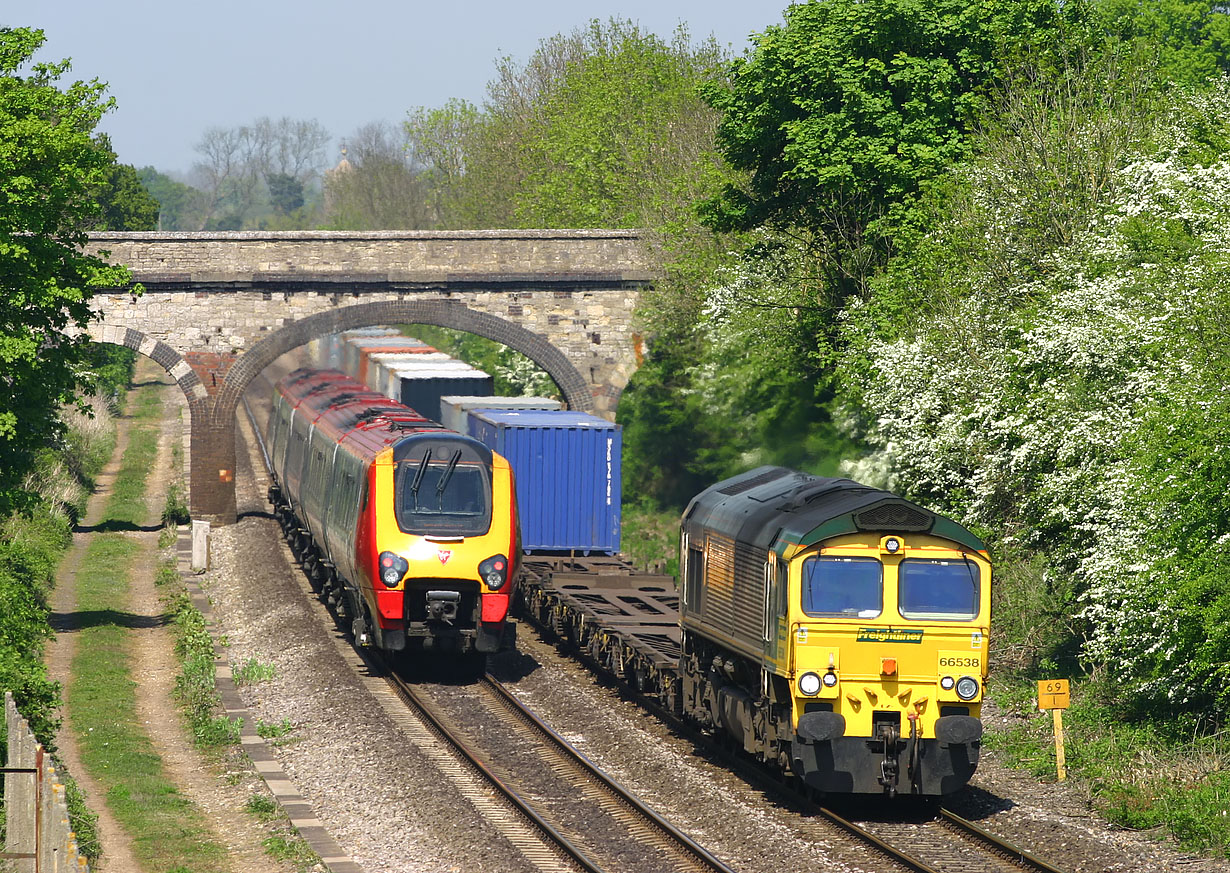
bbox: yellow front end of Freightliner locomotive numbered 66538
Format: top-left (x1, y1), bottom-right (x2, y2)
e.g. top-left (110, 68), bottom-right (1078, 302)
top-left (775, 534), bottom-right (990, 794)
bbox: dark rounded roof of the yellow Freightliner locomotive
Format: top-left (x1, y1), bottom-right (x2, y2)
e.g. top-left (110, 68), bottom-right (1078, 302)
top-left (684, 466), bottom-right (986, 555)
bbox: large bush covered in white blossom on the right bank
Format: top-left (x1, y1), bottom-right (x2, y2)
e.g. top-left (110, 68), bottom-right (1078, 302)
top-left (845, 79), bottom-right (1230, 702)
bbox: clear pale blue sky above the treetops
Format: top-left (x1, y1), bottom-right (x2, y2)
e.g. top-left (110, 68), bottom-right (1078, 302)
top-left (19, 0), bottom-right (787, 178)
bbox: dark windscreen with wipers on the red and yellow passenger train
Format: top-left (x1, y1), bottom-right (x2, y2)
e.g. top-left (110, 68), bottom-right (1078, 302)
top-left (394, 440), bottom-right (491, 536)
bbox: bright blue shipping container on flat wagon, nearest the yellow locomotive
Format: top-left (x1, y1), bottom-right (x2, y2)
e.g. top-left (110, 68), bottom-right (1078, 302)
top-left (469, 409), bottom-right (622, 555)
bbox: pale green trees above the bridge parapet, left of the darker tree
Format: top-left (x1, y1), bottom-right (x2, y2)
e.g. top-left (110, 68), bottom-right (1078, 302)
top-left (418, 20), bottom-right (724, 242)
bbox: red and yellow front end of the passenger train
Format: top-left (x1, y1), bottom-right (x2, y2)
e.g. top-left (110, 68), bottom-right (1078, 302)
top-left (358, 432), bottom-right (520, 652)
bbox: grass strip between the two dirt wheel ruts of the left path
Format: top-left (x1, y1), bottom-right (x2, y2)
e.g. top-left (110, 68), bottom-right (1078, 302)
top-left (66, 387), bottom-right (226, 873)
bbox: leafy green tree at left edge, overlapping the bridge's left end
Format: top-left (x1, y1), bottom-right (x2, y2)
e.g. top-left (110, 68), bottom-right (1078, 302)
top-left (0, 27), bottom-right (132, 513)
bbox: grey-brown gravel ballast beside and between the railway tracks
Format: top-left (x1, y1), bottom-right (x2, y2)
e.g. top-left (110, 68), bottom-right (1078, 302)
top-left (200, 391), bottom-right (1230, 873)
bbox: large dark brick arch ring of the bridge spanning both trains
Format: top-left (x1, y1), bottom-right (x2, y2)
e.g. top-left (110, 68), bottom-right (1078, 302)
top-left (211, 300), bottom-right (594, 424)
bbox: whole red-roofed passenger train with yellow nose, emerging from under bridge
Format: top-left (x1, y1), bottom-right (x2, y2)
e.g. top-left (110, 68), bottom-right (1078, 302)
top-left (266, 369), bottom-right (520, 666)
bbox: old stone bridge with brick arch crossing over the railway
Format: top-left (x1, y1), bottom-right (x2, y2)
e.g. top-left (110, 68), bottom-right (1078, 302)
top-left (89, 230), bottom-right (656, 524)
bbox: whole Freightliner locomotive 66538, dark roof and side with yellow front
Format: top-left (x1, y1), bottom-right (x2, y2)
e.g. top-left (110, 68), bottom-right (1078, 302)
top-left (681, 467), bottom-right (991, 794)
